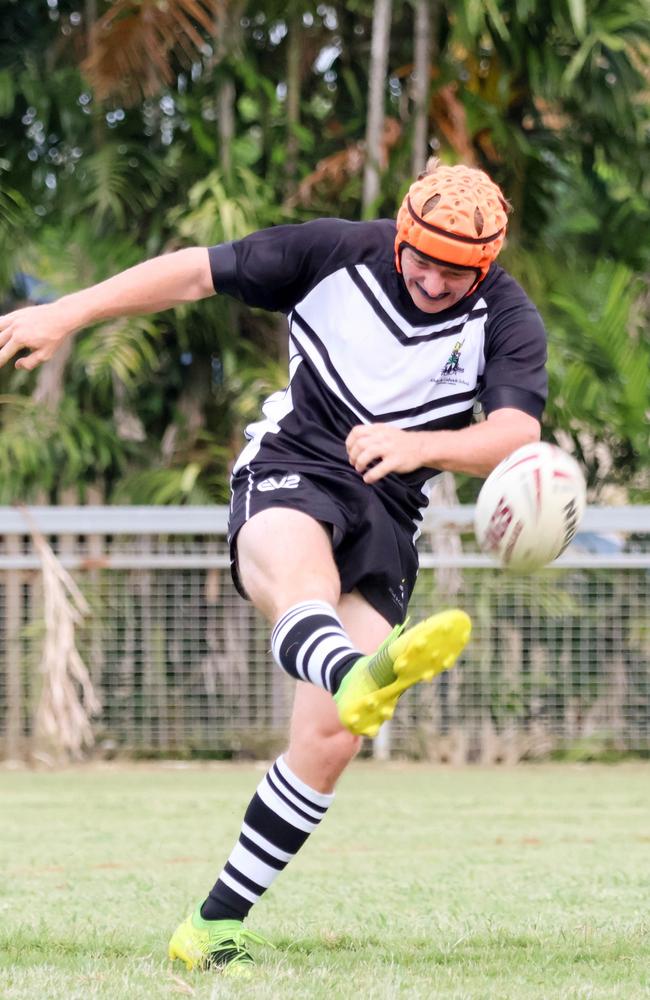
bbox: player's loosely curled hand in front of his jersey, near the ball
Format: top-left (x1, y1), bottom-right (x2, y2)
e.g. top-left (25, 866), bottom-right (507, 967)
top-left (345, 424), bottom-right (425, 483)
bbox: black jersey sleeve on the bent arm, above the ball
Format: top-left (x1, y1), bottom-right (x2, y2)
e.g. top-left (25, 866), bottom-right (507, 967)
top-left (479, 278), bottom-right (548, 420)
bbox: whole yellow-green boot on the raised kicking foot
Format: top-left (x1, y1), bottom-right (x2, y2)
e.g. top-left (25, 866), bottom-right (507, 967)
top-left (334, 608), bottom-right (472, 736)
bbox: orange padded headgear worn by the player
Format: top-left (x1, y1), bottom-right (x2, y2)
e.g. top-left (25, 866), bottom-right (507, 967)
top-left (395, 165), bottom-right (508, 287)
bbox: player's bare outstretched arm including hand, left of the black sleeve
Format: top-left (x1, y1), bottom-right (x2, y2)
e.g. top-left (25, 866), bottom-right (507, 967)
top-left (0, 247), bottom-right (214, 371)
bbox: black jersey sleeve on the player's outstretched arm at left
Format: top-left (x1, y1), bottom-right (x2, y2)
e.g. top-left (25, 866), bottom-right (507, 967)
top-left (208, 219), bottom-right (370, 312)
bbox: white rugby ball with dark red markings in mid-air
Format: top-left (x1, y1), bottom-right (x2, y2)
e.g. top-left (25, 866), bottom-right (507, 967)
top-left (474, 442), bottom-right (586, 573)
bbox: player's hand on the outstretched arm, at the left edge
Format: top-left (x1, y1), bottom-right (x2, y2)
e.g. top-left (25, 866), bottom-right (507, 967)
top-left (0, 302), bottom-right (75, 371)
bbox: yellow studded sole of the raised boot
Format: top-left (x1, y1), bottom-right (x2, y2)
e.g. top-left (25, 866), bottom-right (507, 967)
top-left (337, 609), bottom-right (472, 736)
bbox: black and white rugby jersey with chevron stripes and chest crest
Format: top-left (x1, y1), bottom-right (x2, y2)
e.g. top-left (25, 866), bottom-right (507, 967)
top-left (209, 219), bottom-right (546, 521)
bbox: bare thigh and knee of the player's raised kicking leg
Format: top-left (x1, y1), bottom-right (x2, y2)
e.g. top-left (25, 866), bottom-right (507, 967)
top-left (236, 507), bottom-right (341, 623)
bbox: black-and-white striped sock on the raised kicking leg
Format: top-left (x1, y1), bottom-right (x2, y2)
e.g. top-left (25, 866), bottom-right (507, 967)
top-left (271, 601), bottom-right (361, 694)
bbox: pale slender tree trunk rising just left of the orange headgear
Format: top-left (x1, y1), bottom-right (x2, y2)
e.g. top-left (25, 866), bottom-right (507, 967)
top-left (361, 0), bottom-right (391, 219)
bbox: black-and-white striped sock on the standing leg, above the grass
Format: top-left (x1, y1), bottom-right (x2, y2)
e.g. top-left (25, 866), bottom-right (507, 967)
top-left (201, 757), bottom-right (334, 920)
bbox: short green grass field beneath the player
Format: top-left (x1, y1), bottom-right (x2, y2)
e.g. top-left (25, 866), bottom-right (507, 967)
top-left (0, 763), bottom-right (650, 1000)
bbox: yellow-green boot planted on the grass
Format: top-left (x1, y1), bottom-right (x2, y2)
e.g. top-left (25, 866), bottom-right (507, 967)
top-left (168, 906), bottom-right (270, 977)
